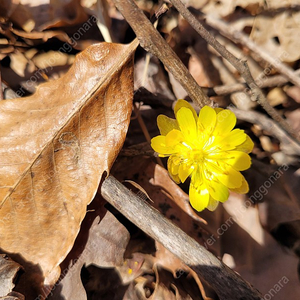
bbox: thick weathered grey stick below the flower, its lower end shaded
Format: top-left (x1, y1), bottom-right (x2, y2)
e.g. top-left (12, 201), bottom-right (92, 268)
top-left (101, 176), bottom-right (262, 300)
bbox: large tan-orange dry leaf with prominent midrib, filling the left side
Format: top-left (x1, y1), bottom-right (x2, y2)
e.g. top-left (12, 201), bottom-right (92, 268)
top-left (0, 42), bottom-right (137, 296)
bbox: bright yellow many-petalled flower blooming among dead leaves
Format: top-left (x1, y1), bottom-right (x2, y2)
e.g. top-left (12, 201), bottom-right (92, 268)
top-left (151, 100), bottom-right (253, 211)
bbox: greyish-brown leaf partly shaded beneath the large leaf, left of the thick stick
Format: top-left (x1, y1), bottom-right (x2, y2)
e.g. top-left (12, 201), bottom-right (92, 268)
top-left (47, 199), bottom-right (129, 300)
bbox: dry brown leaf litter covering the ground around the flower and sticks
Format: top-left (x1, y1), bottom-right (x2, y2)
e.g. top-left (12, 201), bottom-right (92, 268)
top-left (0, 0), bottom-right (300, 300)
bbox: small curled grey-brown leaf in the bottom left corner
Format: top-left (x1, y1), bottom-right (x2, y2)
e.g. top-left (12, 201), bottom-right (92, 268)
top-left (0, 254), bottom-right (21, 297)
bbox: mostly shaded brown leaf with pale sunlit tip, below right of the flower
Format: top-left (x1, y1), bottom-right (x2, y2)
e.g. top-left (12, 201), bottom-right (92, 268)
top-left (220, 194), bottom-right (300, 300)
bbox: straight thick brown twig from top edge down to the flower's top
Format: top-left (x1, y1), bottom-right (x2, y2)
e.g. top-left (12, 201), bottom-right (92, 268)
top-left (113, 0), bottom-right (211, 107)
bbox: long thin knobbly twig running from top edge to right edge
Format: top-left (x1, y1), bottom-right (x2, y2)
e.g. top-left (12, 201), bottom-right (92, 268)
top-left (170, 0), bottom-right (298, 140)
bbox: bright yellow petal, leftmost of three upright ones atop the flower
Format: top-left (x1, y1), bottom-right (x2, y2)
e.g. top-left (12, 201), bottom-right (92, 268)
top-left (176, 107), bottom-right (197, 142)
